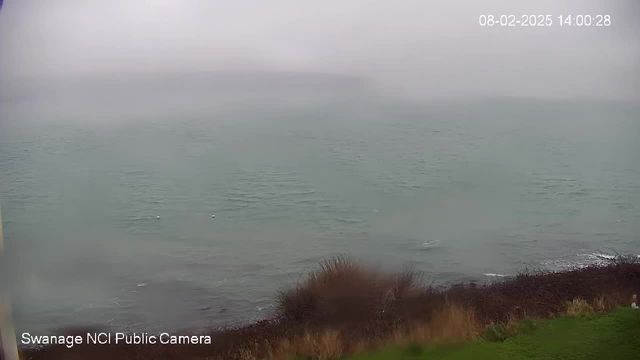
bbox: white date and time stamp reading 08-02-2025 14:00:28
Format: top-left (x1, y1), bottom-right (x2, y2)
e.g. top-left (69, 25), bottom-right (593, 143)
top-left (478, 14), bottom-right (611, 27)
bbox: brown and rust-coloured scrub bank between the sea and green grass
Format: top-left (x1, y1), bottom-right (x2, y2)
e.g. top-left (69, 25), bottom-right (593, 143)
top-left (13, 256), bottom-right (640, 360)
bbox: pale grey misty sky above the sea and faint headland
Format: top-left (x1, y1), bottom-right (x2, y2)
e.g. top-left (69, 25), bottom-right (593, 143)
top-left (0, 0), bottom-right (640, 99)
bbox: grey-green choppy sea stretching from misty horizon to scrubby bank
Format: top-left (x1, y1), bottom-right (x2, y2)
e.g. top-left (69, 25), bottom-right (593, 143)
top-left (0, 86), bottom-right (640, 332)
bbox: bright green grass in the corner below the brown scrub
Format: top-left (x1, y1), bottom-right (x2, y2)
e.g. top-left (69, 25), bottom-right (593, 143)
top-left (345, 308), bottom-right (640, 360)
